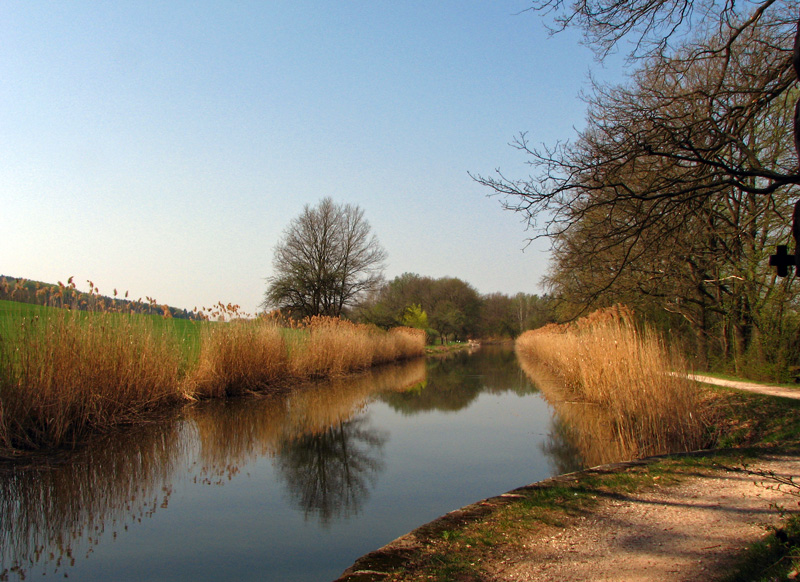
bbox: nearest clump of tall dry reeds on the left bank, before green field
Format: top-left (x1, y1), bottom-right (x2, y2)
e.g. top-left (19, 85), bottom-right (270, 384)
top-left (0, 309), bottom-right (181, 448)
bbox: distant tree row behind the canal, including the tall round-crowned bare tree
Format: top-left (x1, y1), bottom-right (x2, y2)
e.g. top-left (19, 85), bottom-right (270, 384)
top-left (262, 198), bottom-right (552, 343)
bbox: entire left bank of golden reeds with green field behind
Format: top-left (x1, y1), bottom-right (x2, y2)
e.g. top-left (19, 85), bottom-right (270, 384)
top-left (0, 301), bottom-right (425, 453)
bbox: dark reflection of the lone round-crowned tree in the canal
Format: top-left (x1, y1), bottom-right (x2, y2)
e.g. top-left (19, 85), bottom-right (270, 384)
top-left (276, 415), bottom-right (389, 527)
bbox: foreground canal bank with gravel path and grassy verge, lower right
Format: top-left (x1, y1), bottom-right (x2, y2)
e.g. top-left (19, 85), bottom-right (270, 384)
top-left (338, 378), bottom-right (800, 582)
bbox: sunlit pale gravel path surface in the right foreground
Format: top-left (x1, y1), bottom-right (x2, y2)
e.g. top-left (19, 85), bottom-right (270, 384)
top-left (484, 456), bottom-right (800, 582)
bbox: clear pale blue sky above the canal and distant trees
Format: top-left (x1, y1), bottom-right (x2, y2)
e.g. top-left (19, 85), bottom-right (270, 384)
top-left (0, 0), bottom-right (624, 312)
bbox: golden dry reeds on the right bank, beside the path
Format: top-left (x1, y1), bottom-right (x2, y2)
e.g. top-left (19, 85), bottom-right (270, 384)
top-left (516, 307), bottom-right (707, 458)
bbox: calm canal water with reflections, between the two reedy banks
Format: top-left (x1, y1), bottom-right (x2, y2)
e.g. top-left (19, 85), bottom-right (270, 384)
top-left (0, 348), bottom-right (582, 581)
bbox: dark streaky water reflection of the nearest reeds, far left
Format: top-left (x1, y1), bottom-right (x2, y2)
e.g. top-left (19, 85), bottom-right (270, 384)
top-left (0, 415), bottom-right (192, 580)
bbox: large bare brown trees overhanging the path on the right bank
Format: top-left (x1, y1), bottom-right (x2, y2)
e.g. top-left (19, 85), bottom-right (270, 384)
top-left (474, 0), bottom-right (800, 378)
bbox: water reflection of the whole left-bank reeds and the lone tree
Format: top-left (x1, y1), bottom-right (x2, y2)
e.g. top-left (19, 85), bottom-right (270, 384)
top-left (0, 360), bottom-right (426, 580)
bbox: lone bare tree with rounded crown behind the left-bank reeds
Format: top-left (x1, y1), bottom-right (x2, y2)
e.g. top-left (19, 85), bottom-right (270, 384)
top-left (262, 198), bottom-right (386, 317)
